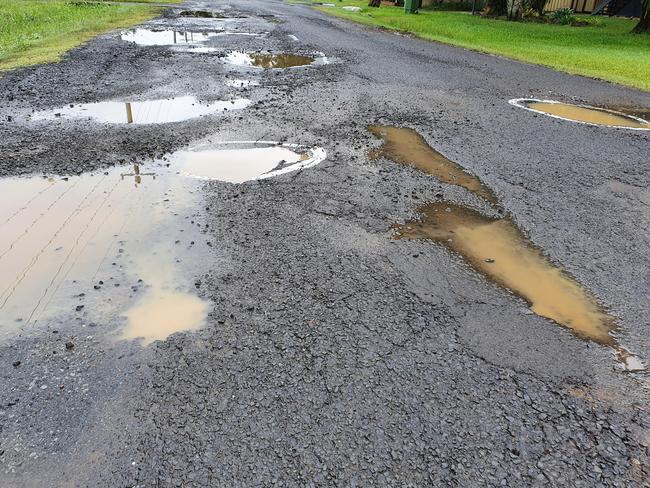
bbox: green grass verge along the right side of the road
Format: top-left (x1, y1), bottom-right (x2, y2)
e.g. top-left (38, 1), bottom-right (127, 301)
top-left (308, 0), bottom-right (650, 91)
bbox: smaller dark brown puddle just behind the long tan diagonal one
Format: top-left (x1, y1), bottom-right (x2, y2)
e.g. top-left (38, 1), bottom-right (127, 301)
top-left (369, 125), bottom-right (497, 203)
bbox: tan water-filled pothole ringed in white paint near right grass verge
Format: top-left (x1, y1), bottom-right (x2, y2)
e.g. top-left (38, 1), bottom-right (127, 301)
top-left (510, 98), bottom-right (650, 130)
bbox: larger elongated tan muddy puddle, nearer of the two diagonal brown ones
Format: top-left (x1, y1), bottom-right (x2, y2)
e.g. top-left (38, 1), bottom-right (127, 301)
top-left (395, 202), bottom-right (615, 346)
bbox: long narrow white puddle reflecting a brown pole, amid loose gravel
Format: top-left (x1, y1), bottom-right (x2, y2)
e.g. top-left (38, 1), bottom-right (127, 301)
top-left (32, 96), bottom-right (251, 124)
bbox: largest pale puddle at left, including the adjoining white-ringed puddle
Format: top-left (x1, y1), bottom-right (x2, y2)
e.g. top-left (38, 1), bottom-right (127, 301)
top-left (0, 142), bottom-right (325, 343)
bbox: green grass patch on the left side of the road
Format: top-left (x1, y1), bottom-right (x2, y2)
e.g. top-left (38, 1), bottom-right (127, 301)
top-left (0, 0), bottom-right (175, 70)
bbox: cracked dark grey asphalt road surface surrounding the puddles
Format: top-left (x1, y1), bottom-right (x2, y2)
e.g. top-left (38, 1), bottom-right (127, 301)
top-left (0, 0), bottom-right (650, 487)
